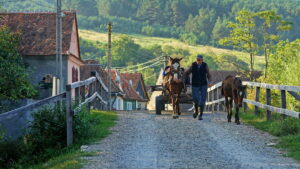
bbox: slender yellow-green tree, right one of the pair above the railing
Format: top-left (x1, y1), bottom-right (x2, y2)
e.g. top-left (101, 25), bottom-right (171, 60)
top-left (255, 11), bottom-right (291, 78)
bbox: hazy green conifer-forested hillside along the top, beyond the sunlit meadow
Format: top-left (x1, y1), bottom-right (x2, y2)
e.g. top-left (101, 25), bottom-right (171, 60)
top-left (0, 0), bottom-right (300, 46)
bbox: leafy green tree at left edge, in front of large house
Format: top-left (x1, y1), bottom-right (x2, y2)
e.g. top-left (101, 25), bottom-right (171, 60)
top-left (0, 26), bottom-right (36, 101)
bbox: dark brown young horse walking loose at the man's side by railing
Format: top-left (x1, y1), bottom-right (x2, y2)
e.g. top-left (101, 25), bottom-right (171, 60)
top-left (221, 75), bottom-right (246, 124)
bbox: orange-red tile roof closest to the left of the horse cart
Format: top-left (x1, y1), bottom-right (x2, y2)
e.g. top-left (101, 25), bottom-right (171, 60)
top-left (121, 73), bottom-right (149, 101)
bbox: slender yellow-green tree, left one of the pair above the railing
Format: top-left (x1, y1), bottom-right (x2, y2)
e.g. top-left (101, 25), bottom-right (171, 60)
top-left (219, 10), bottom-right (258, 80)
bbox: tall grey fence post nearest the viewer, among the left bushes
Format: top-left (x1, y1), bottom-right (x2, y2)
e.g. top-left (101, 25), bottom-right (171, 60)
top-left (66, 84), bottom-right (73, 146)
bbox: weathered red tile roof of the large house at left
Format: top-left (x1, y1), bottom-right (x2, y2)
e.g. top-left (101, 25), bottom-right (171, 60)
top-left (0, 12), bottom-right (76, 55)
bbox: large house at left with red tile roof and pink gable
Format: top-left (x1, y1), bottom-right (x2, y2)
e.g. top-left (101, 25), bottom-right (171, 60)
top-left (0, 11), bottom-right (84, 98)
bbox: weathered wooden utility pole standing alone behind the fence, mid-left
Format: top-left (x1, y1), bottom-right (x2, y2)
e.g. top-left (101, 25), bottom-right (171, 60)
top-left (107, 22), bottom-right (112, 111)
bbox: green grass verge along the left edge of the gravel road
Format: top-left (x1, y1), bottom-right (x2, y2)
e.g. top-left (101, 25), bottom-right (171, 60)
top-left (20, 110), bottom-right (118, 169)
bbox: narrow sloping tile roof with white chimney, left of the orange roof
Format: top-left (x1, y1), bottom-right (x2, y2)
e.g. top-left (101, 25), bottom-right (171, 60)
top-left (111, 70), bottom-right (144, 101)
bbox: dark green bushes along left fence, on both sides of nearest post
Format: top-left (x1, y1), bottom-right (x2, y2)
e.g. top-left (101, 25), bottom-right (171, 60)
top-left (0, 104), bottom-right (100, 168)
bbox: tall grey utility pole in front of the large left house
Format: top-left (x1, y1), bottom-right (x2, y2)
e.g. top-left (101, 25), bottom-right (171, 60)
top-left (56, 0), bottom-right (64, 93)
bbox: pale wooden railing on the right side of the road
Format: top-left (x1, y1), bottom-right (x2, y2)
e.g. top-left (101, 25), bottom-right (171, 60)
top-left (206, 82), bottom-right (300, 120)
